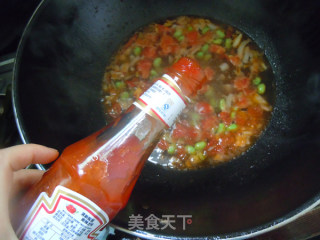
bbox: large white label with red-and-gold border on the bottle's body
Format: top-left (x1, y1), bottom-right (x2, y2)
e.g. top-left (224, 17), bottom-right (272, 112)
top-left (17, 186), bottom-right (109, 240)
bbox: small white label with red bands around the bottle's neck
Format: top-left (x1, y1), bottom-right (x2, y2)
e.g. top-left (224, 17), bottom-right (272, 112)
top-left (134, 74), bottom-right (186, 127)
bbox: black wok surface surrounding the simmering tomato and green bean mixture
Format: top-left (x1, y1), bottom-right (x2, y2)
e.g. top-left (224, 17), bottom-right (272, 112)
top-left (13, 0), bottom-right (320, 238)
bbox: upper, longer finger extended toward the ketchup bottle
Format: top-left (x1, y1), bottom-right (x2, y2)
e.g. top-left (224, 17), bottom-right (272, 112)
top-left (0, 144), bottom-right (59, 171)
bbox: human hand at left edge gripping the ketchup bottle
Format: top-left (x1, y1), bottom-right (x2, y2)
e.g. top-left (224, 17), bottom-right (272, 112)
top-left (0, 144), bottom-right (59, 240)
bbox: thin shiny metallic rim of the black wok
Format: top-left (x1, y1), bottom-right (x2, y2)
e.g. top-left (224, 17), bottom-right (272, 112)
top-left (11, 0), bottom-right (320, 240)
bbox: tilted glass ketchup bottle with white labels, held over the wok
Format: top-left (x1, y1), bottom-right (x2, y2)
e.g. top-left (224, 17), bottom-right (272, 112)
top-left (17, 57), bottom-right (205, 240)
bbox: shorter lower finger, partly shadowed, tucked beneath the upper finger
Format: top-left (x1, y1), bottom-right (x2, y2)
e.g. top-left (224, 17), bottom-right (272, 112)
top-left (10, 169), bottom-right (45, 197)
